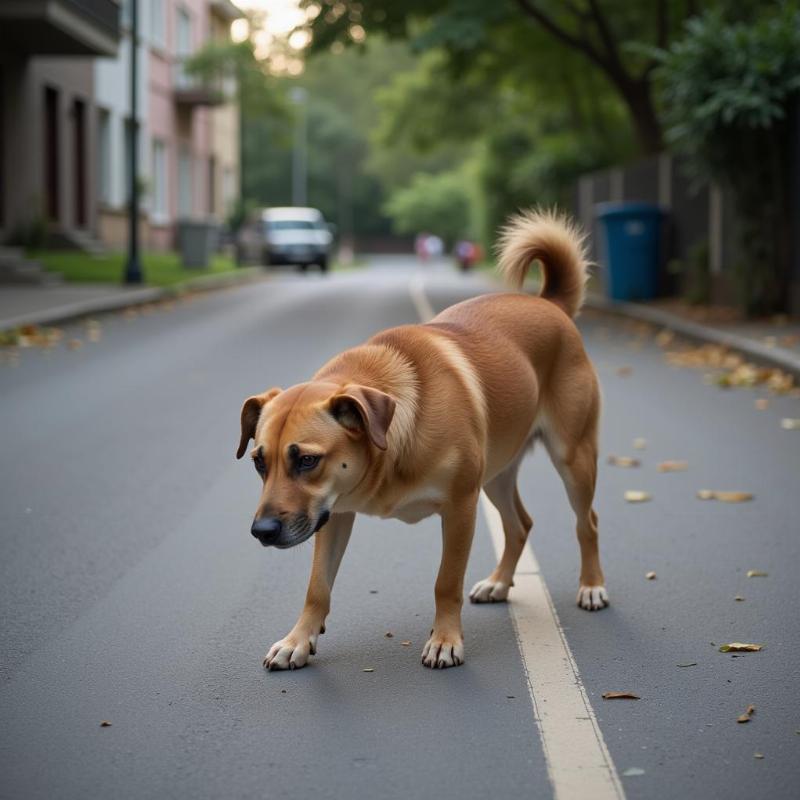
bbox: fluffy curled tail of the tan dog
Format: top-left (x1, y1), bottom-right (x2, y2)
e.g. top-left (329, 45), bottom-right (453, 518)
top-left (497, 209), bottom-right (589, 317)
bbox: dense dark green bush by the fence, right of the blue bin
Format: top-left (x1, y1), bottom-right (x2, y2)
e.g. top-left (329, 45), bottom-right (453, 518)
top-left (658, 8), bottom-right (800, 313)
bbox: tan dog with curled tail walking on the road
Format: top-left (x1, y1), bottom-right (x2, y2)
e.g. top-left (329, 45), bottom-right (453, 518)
top-left (237, 212), bottom-right (608, 669)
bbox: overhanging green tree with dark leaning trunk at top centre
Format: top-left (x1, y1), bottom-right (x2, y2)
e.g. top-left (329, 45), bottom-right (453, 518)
top-left (304, 0), bottom-right (708, 153)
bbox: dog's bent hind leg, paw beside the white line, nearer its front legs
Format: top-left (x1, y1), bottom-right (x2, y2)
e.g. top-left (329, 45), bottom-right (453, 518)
top-left (469, 460), bottom-right (533, 603)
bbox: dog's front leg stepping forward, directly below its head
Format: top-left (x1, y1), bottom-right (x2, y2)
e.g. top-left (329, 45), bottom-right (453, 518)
top-left (264, 513), bottom-right (355, 670)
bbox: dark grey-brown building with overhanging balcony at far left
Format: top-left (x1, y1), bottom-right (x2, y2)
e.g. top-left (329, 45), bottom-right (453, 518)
top-left (0, 0), bottom-right (120, 246)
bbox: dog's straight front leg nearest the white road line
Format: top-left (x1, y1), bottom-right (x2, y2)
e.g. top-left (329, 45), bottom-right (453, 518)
top-left (422, 491), bottom-right (478, 669)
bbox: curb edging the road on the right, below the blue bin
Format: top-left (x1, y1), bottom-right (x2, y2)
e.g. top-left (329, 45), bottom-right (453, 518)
top-left (585, 294), bottom-right (800, 381)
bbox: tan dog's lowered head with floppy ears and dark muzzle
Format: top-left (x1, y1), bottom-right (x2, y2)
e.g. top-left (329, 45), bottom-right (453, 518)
top-left (236, 381), bottom-right (395, 548)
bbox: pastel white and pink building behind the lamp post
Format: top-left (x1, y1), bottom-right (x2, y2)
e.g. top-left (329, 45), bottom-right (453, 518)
top-left (95, 0), bottom-right (241, 250)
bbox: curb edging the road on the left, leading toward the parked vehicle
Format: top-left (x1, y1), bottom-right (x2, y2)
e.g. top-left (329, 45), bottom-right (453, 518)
top-left (0, 267), bottom-right (264, 331)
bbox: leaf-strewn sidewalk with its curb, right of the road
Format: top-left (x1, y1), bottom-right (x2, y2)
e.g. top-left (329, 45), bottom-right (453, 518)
top-left (586, 293), bottom-right (800, 381)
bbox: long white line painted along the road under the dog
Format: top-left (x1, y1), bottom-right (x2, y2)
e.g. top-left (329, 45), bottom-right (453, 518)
top-left (408, 276), bottom-right (625, 800)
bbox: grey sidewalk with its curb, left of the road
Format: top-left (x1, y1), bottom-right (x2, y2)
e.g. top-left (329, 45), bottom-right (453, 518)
top-left (0, 267), bottom-right (264, 331)
